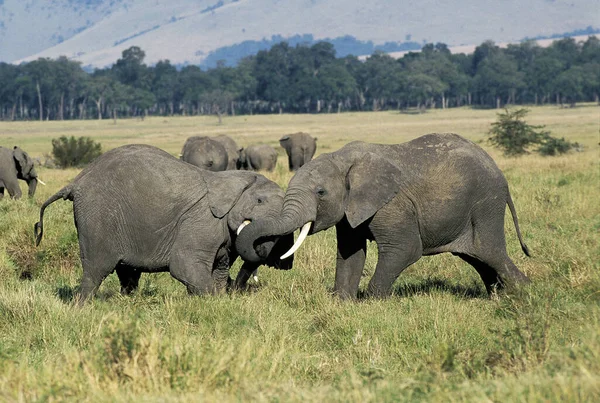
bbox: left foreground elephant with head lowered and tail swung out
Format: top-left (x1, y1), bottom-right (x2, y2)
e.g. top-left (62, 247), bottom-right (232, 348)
top-left (35, 145), bottom-right (293, 303)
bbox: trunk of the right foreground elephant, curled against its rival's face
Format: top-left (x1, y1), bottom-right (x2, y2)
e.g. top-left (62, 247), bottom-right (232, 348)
top-left (236, 190), bottom-right (317, 262)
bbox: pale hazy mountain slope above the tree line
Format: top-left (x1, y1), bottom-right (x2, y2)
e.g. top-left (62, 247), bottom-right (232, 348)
top-left (0, 0), bottom-right (600, 67)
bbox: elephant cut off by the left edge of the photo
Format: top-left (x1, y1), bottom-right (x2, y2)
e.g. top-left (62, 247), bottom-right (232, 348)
top-left (0, 146), bottom-right (38, 199)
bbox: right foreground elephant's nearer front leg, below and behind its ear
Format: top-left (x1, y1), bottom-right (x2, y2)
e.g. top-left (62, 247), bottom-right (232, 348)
top-left (367, 215), bottom-right (423, 297)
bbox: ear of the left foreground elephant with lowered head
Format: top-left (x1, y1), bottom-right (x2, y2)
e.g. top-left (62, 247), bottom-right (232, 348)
top-left (204, 171), bottom-right (256, 218)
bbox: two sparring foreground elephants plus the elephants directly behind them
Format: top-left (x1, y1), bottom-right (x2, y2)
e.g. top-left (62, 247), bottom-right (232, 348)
top-left (8, 133), bottom-right (529, 303)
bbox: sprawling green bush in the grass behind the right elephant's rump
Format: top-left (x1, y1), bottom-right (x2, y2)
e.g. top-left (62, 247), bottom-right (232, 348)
top-left (489, 108), bottom-right (578, 156)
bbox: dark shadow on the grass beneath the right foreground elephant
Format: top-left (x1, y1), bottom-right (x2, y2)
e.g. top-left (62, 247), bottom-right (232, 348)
top-left (358, 278), bottom-right (489, 299)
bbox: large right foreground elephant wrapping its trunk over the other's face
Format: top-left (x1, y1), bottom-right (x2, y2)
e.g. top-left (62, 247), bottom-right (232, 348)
top-left (237, 134), bottom-right (529, 298)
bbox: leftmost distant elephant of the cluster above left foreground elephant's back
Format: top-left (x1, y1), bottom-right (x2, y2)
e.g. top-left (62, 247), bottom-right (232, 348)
top-left (180, 136), bottom-right (229, 172)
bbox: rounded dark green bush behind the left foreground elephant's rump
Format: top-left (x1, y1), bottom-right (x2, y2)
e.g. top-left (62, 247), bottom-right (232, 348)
top-left (52, 136), bottom-right (102, 168)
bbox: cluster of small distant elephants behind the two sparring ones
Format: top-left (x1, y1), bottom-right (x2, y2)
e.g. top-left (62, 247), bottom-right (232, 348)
top-left (179, 132), bottom-right (317, 172)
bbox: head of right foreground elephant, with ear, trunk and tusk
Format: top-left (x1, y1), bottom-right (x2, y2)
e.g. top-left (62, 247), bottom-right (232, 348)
top-left (236, 151), bottom-right (401, 261)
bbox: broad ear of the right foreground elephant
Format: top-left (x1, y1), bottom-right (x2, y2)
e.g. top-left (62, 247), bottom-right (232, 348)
top-left (346, 153), bottom-right (401, 228)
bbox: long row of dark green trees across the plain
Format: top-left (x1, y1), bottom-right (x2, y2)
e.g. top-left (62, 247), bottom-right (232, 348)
top-left (0, 37), bottom-right (600, 120)
